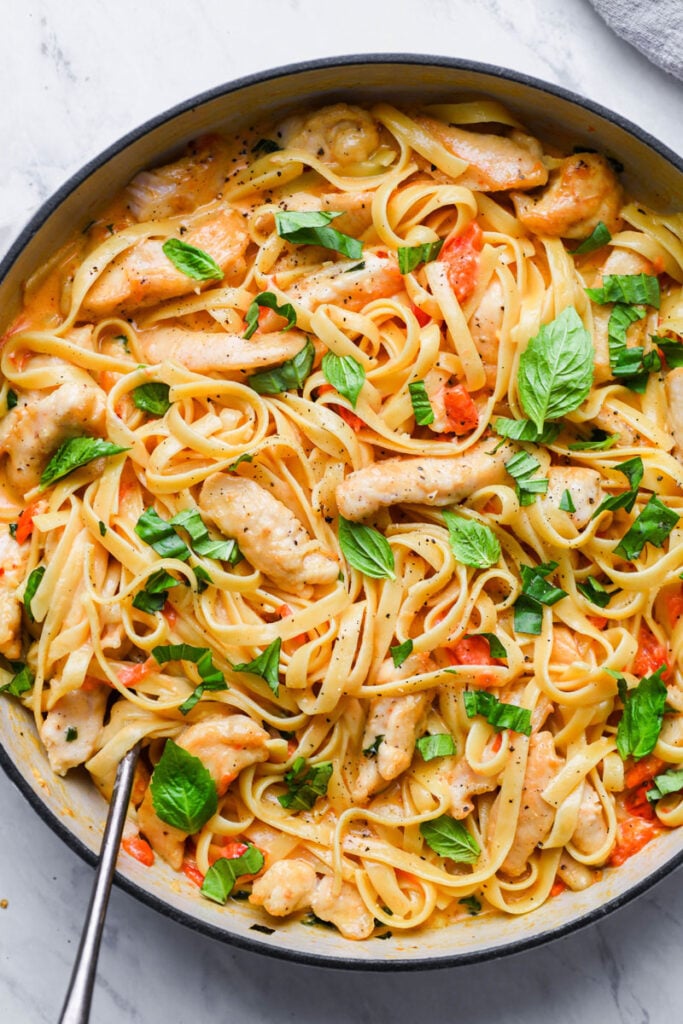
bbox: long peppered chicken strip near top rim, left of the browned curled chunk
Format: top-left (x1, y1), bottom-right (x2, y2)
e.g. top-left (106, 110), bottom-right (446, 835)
top-left (415, 115), bottom-right (548, 191)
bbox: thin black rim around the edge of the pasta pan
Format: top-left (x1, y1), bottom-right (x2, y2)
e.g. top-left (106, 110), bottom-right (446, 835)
top-left (0, 53), bottom-right (683, 972)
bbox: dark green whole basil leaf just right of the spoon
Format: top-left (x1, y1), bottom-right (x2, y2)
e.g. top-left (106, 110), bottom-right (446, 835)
top-left (150, 739), bottom-right (218, 835)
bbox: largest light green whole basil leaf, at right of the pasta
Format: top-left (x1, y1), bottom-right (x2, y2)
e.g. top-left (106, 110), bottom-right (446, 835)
top-left (517, 306), bottom-right (595, 432)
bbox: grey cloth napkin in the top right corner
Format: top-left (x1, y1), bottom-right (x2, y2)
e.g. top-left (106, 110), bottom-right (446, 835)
top-left (591, 0), bottom-right (683, 79)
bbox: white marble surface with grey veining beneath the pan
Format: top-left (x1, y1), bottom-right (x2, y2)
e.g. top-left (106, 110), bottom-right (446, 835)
top-left (0, 0), bottom-right (683, 1024)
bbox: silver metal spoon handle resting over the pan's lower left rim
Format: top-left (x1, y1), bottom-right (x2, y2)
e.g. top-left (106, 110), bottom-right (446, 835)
top-left (59, 743), bottom-right (140, 1024)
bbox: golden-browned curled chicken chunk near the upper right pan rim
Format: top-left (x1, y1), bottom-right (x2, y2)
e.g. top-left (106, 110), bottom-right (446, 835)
top-left (510, 153), bottom-right (623, 239)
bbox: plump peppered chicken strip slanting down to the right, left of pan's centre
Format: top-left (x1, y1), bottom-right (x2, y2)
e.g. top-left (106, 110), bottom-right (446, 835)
top-left (200, 473), bottom-right (339, 592)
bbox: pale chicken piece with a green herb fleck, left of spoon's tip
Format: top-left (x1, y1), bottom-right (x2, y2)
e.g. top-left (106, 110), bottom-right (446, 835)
top-left (40, 686), bottom-right (109, 775)
